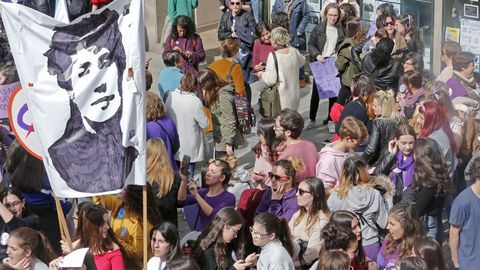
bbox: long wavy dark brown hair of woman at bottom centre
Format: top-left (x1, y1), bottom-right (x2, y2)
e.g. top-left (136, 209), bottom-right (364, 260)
top-left (195, 207), bottom-right (244, 270)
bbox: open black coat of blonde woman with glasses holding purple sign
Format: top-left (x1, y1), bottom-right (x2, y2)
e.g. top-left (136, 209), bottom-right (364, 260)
top-left (308, 21), bottom-right (345, 62)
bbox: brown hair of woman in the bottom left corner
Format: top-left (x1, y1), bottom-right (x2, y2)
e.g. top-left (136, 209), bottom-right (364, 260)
top-left (10, 227), bottom-right (56, 264)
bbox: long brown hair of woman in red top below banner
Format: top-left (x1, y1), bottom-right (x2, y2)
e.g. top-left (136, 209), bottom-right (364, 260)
top-left (76, 204), bottom-right (120, 255)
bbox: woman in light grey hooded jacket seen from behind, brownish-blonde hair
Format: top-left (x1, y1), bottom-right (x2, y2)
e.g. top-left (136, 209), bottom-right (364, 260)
top-left (328, 156), bottom-right (388, 258)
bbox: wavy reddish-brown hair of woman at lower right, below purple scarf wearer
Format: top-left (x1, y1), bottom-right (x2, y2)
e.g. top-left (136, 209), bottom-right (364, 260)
top-left (385, 202), bottom-right (423, 260)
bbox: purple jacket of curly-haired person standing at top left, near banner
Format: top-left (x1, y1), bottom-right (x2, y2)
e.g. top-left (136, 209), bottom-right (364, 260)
top-left (162, 34), bottom-right (205, 75)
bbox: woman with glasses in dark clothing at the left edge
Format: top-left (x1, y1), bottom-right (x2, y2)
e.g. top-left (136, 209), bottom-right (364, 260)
top-left (0, 185), bottom-right (40, 261)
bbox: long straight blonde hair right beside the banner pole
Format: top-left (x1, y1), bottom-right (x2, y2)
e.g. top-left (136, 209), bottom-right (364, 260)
top-left (147, 138), bottom-right (175, 198)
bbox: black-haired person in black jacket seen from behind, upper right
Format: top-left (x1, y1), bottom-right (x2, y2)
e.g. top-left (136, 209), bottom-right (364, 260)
top-left (362, 37), bottom-right (403, 91)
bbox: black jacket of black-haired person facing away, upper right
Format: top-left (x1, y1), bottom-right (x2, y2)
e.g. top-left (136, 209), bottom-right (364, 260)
top-left (362, 53), bottom-right (403, 91)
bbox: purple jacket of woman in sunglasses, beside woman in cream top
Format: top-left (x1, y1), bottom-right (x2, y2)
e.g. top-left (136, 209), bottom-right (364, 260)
top-left (255, 188), bottom-right (298, 221)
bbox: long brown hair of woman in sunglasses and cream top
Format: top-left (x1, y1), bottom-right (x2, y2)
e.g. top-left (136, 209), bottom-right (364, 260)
top-left (293, 177), bottom-right (330, 235)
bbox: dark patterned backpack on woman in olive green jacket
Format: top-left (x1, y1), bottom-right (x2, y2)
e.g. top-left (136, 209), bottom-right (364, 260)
top-left (226, 63), bottom-right (255, 134)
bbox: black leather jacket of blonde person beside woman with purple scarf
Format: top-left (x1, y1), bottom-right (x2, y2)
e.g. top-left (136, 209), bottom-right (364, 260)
top-left (362, 117), bottom-right (407, 165)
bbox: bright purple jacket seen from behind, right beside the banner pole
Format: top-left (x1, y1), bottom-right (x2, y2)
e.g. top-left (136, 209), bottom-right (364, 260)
top-left (147, 116), bottom-right (180, 172)
